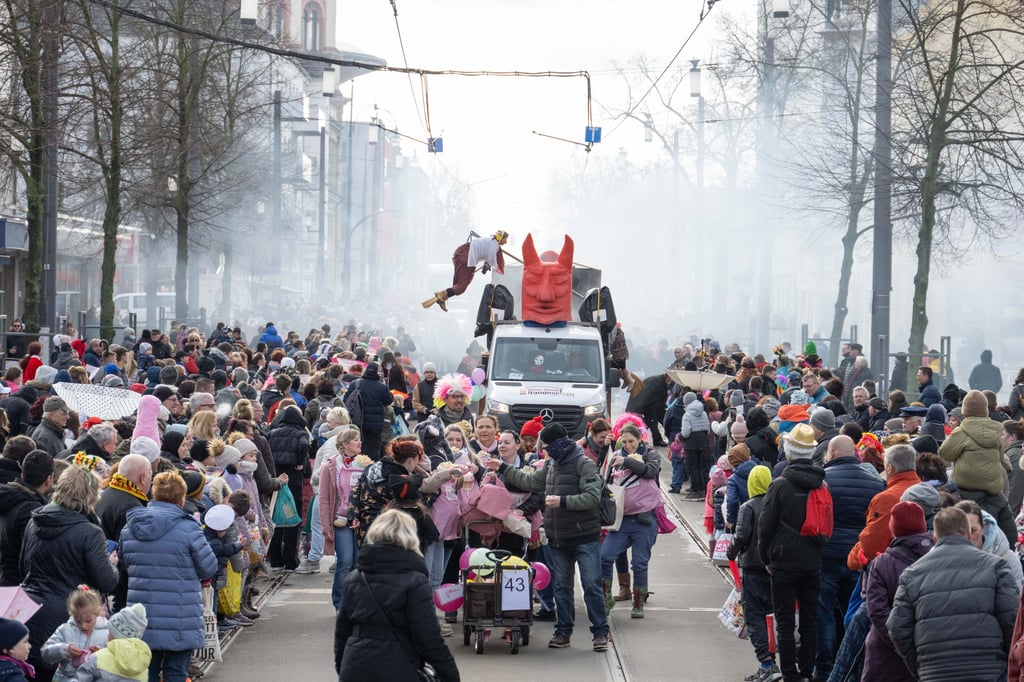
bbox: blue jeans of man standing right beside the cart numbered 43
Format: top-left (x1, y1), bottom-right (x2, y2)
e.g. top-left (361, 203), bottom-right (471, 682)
top-left (548, 541), bottom-right (614, 637)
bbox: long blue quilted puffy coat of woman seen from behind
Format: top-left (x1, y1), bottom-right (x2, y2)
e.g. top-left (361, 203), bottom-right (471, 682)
top-left (118, 501), bottom-right (217, 651)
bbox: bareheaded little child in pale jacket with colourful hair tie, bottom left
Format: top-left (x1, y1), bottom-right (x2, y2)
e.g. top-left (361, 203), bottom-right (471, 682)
top-left (40, 585), bottom-right (106, 682)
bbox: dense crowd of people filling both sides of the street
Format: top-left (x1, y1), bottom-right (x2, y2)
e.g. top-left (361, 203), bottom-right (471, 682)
top-left (0, 315), bottom-right (1024, 682)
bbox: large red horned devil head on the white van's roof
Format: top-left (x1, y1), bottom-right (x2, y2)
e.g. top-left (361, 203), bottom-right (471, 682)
top-left (522, 235), bottom-right (572, 325)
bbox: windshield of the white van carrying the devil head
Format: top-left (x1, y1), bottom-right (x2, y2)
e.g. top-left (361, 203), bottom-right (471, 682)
top-left (489, 338), bottom-right (602, 384)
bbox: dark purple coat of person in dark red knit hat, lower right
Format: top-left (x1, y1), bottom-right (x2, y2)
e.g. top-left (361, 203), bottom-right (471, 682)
top-left (861, 532), bottom-right (935, 682)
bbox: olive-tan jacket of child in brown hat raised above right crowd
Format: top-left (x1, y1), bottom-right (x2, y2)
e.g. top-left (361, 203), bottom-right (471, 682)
top-left (939, 417), bottom-right (1006, 495)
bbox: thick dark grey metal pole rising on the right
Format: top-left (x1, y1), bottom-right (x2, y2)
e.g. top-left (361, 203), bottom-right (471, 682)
top-left (871, 0), bottom-right (893, 387)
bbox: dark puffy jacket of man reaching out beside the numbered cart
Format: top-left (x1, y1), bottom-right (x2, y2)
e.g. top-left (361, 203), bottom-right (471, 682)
top-left (500, 443), bottom-right (604, 547)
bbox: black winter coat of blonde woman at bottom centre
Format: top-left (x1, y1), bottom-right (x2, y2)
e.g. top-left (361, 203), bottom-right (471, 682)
top-left (334, 545), bottom-right (459, 682)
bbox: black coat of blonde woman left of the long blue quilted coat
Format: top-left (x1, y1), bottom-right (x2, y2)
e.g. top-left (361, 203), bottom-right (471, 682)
top-left (22, 504), bottom-right (118, 665)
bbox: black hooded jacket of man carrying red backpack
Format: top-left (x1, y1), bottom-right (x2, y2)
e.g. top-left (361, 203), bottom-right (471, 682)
top-left (758, 460), bottom-right (825, 573)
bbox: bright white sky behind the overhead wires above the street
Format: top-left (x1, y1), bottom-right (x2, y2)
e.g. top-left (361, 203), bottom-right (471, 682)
top-left (337, 0), bottom-right (724, 228)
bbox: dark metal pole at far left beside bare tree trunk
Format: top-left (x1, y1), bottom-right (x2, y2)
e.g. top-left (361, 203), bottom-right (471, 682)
top-left (39, 0), bottom-right (60, 327)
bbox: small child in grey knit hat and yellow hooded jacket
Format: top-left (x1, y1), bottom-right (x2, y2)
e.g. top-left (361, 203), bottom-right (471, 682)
top-left (75, 604), bottom-right (153, 682)
